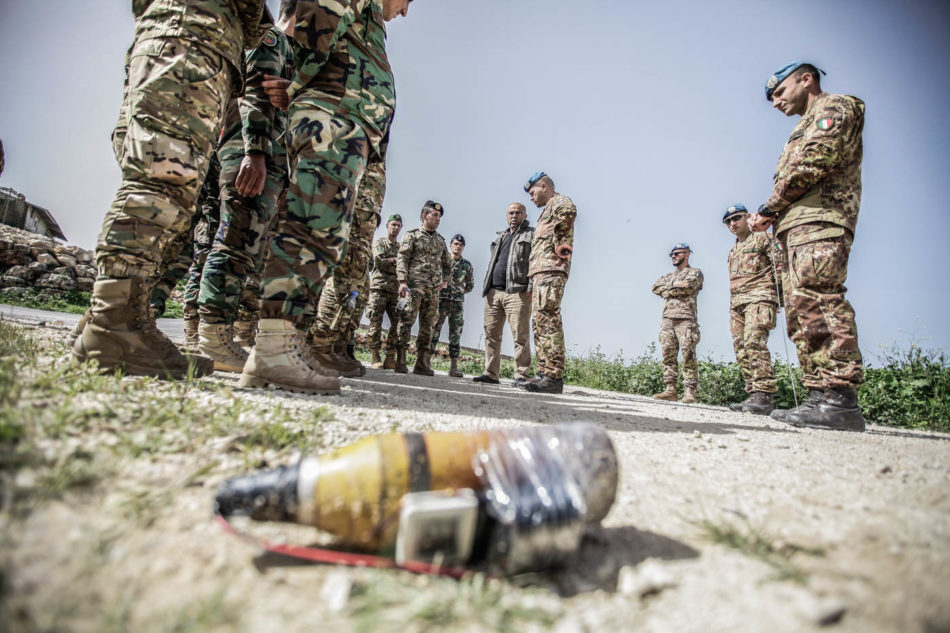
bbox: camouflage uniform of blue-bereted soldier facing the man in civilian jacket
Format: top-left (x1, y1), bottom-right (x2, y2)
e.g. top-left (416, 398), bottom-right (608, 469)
top-left (528, 193), bottom-right (577, 379)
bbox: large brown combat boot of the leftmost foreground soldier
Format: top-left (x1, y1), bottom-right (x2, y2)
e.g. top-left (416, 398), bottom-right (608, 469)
top-left (73, 279), bottom-right (214, 380)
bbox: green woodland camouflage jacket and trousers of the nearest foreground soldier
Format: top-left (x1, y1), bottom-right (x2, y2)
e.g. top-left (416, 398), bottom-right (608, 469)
top-left (261, 0), bottom-right (396, 324)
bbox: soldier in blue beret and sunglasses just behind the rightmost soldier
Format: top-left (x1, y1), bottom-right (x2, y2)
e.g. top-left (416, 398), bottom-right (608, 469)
top-left (722, 204), bottom-right (778, 415)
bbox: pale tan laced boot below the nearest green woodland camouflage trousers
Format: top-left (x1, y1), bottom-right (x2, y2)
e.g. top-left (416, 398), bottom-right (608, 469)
top-left (238, 319), bottom-right (340, 395)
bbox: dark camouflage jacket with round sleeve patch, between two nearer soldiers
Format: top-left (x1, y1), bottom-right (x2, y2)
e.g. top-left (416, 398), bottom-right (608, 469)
top-left (221, 26), bottom-right (293, 160)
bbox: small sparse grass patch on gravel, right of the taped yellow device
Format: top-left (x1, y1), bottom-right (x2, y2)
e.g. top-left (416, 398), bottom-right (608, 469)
top-left (699, 519), bottom-right (825, 585)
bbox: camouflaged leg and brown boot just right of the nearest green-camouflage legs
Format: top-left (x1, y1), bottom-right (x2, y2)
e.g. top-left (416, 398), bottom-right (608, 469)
top-left (309, 160), bottom-right (386, 376)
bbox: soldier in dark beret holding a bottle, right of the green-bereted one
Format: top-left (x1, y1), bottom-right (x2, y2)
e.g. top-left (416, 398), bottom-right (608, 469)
top-left (395, 200), bottom-right (452, 376)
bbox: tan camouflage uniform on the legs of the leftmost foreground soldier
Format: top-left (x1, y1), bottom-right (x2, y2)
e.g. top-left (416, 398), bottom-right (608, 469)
top-left (96, 0), bottom-right (268, 280)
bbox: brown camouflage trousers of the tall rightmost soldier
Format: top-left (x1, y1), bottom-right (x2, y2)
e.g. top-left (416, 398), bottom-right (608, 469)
top-left (780, 225), bottom-right (864, 389)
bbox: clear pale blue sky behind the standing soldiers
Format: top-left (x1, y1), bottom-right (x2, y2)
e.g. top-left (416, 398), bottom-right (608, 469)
top-left (0, 0), bottom-right (950, 362)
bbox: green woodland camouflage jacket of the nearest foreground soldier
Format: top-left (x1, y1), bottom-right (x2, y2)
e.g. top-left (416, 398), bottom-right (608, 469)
top-left (289, 0), bottom-right (396, 157)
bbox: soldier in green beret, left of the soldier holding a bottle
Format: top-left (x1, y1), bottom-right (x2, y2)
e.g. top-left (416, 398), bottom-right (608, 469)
top-left (367, 213), bottom-right (402, 369)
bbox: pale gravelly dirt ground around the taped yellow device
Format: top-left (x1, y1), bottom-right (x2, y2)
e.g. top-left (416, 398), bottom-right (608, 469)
top-left (0, 320), bottom-right (950, 633)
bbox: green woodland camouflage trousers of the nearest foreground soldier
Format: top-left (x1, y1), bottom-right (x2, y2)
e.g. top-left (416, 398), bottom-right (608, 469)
top-left (261, 99), bottom-right (369, 325)
